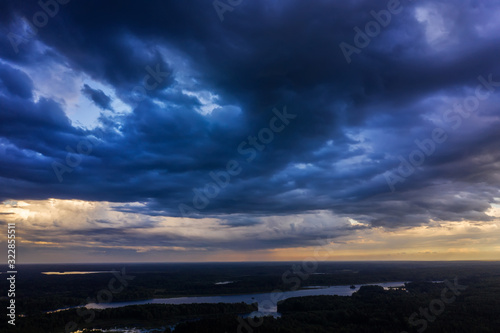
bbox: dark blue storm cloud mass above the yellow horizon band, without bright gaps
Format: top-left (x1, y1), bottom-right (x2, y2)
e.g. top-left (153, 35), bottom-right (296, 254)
top-left (0, 0), bottom-right (500, 239)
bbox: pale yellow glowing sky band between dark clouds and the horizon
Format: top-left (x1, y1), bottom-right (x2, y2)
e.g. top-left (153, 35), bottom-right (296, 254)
top-left (0, 199), bottom-right (500, 263)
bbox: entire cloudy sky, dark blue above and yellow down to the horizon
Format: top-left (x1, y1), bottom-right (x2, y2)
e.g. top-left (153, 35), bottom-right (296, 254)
top-left (0, 0), bottom-right (500, 263)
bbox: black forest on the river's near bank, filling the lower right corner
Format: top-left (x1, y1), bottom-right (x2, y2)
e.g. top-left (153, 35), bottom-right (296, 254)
top-left (174, 275), bottom-right (500, 333)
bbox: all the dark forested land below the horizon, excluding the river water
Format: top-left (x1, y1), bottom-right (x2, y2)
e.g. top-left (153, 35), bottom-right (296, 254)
top-left (0, 262), bottom-right (500, 333)
